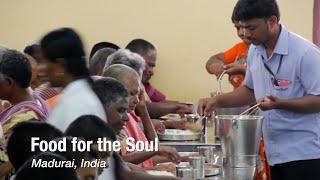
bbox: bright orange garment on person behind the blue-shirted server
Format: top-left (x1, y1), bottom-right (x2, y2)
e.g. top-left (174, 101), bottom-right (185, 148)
top-left (223, 41), bottom-right (249, 88)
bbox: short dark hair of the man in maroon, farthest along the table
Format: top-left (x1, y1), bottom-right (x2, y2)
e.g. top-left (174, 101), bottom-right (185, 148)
top-left (126, 39), bottom-right (156, 56)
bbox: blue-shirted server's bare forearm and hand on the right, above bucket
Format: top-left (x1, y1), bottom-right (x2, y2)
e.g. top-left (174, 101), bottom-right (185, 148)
top-left (261, 95), bottom-right (320, 113)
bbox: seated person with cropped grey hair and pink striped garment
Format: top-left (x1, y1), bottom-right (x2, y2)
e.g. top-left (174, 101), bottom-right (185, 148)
top-left (98, 64), bottom-right (180, 173)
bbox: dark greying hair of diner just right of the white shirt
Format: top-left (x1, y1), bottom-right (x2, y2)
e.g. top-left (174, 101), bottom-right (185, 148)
top-left (92, 78), bottom-right (129, 107)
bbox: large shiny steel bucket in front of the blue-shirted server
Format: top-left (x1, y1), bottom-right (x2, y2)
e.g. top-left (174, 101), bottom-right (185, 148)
top-left (216, 115), bottom-right (263, 168)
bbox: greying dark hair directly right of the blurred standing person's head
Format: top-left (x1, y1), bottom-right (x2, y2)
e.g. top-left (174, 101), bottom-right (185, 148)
top-left (89, 48), bottom-right (116, 75)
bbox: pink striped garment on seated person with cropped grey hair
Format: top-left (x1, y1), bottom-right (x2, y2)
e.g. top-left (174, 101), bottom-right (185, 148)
top-left (121, 111), bottom-right (153, 168)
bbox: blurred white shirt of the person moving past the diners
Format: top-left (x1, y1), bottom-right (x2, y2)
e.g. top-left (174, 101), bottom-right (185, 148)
top-left (48, 79), bottom-right (107, 132)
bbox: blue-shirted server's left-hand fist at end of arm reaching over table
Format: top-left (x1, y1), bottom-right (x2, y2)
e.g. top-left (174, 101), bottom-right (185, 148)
top-left (197, 97), bottom-right (217, 116)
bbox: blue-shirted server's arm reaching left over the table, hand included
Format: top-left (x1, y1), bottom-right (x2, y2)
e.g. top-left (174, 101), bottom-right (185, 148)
top-left (198, 86), bottom-right (255, 116)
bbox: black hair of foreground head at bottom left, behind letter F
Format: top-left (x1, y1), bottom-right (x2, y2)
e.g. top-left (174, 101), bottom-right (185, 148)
top-left (7, 119), bottom-right (63, 170)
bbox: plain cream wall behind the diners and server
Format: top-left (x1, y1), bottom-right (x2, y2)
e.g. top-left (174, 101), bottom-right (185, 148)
top-left (0, 0), bottom-right (313, 101)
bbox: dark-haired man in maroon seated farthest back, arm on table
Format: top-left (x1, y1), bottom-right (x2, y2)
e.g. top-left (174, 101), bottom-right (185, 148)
top-left (126, 39), bottom-right (191, 118)
